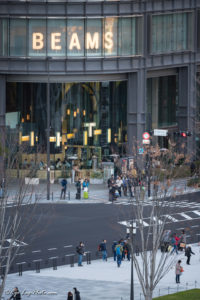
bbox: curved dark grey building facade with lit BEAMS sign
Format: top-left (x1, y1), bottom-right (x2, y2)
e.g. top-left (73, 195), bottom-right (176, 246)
top-left (0, 0), bottom-right (200, 178)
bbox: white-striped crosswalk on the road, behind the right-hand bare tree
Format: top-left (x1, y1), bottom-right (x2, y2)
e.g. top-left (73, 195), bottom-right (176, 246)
top-left (118, 210), bottom-right (200, 227)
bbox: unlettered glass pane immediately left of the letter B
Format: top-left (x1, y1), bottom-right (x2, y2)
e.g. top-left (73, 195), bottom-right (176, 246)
top-left (10, 19), bottom-right (26, 56)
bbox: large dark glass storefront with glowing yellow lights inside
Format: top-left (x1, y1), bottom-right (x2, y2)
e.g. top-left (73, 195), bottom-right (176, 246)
top-left (6, 81), bottom-right (127, 177)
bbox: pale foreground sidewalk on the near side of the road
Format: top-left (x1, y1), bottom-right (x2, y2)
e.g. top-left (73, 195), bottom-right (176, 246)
top-left (5, 244), bottom-right (200, 300)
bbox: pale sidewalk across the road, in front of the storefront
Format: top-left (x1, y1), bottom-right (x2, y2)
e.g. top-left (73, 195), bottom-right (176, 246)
top-left (5, 178), bottom-right (200, 204)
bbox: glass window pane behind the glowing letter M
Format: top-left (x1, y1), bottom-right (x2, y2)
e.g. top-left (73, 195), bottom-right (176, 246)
top-left (85, 19), bottom-right (102, 56)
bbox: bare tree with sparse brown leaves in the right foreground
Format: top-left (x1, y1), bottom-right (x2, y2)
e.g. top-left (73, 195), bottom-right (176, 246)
top-left (125, 143), bottom-right (192, 300)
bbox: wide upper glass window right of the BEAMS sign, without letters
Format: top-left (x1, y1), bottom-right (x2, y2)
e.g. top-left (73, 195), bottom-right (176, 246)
top-left (151, 13), bottom-right (193, 53)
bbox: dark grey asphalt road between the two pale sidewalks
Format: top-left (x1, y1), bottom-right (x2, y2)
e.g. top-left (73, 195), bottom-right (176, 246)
top-left (3, 193), bottom-right (200, 272)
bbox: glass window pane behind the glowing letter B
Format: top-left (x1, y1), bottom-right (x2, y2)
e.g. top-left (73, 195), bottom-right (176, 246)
top-left (29, 19), bottom-right (46, 56)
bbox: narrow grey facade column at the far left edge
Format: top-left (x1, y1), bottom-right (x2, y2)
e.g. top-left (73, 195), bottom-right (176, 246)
top-left (0, 75), bottom-right (6, 184)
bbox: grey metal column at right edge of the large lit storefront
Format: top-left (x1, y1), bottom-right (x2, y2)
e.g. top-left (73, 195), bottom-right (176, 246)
top-left (127, 69), bottom-right (146, 155)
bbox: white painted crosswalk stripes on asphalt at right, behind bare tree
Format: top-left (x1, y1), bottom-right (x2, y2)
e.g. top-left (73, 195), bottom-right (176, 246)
top-left (118, 210), bottom-right (200, 227)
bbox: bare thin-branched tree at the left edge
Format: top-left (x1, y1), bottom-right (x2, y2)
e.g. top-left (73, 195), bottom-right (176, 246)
top-left (0, 130), bottom-right (42, 298)
